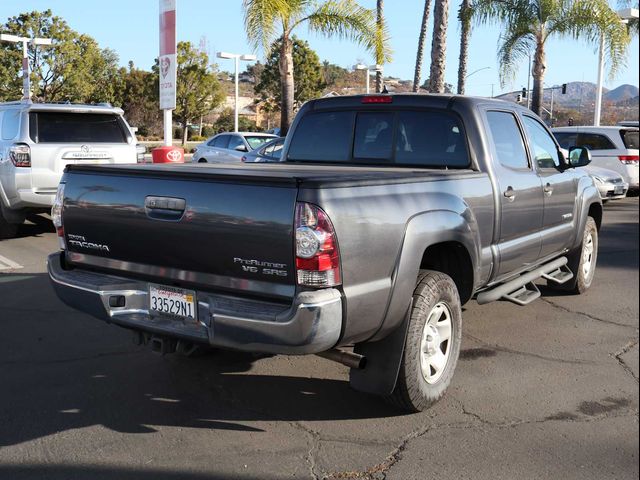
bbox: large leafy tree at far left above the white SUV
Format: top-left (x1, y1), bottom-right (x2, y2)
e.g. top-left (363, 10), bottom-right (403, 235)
top-left (0, 10), bottom-right (118, 102)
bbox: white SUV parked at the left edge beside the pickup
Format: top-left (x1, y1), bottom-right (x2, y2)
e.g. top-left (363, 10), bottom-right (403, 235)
top-left (0, 101), bottom-right (144, 238)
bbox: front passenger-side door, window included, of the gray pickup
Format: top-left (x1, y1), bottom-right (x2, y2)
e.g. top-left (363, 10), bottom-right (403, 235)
top-left (522, 115), bottom-right (578, 257)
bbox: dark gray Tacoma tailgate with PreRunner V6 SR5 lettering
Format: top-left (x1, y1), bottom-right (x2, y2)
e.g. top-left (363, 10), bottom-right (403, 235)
top-left (63, 167), bottom-right (297, 300)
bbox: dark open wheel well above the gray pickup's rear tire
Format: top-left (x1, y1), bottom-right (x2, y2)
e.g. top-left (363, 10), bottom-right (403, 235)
top-left (420, 242), bottom-right (473, 304)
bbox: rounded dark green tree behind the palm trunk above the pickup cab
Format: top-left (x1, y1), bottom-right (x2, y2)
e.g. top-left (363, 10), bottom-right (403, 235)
top-left (254, 36), bottom-right (326, 108)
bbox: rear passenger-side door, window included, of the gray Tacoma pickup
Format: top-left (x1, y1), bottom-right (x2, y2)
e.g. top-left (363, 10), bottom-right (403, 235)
top-left (486, 110), bottom-right (544, 277)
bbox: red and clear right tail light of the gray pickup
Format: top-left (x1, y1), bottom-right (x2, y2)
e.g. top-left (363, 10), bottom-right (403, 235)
top-left (295, 202), bottom-right (342, 287)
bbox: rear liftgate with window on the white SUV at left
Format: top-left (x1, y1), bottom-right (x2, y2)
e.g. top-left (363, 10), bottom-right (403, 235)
top-left (28, 111), bottom-right (137, 194)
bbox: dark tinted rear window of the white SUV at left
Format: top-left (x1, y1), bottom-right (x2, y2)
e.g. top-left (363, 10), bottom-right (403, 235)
top-left (29, 112), bottom-right (127, 143)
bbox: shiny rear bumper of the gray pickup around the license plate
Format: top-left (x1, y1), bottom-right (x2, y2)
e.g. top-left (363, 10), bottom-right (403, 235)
top-left (47, 253), bottom-right (342, 355)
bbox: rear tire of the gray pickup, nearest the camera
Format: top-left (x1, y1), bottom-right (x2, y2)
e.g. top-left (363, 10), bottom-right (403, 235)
top-left (386, 270), bottom-right (462, 412)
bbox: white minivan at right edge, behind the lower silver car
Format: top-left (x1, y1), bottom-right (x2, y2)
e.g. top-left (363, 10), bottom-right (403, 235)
top-left (553, 126), bottom-right (640, 193)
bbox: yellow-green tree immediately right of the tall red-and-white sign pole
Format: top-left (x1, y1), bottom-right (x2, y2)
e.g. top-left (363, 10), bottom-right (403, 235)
top-left (164, 42), bottom-right (224, 145)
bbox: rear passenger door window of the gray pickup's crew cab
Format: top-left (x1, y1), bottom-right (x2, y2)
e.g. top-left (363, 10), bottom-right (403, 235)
top-left (487, 112), bottom-right (529, 168)
